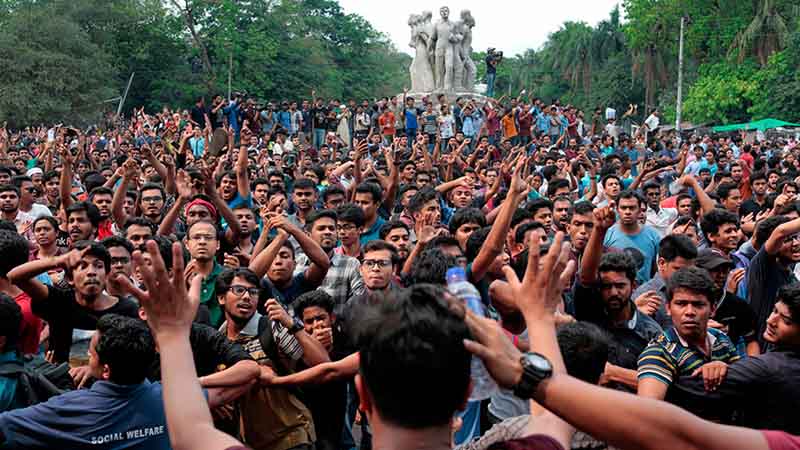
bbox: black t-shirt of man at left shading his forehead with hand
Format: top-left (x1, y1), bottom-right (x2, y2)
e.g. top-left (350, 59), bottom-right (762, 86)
top-left (31, 286), bottom-right (139, 362)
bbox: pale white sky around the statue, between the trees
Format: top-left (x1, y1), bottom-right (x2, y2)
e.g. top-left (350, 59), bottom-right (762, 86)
top-left (339, 0), bottom-right (622, 56)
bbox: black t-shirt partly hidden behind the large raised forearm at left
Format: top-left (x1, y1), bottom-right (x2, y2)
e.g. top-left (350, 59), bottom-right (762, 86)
top-left (147, 323), bottom-right (253, 381)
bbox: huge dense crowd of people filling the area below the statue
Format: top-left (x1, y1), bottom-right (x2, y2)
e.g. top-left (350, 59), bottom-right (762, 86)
top-left (0, 91), bottom-right (800, 450)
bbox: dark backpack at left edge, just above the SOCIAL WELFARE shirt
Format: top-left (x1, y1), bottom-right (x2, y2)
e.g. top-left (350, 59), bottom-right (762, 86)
top-left (0, 355), bottom-right (75, 407)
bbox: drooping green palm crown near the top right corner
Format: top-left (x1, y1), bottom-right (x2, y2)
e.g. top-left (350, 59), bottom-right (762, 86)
top-left (730, 0), bottom-right (790, 66)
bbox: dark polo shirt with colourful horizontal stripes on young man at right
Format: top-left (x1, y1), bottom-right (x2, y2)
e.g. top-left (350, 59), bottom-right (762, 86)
top-left (638, 327), bottom-right (739, 385)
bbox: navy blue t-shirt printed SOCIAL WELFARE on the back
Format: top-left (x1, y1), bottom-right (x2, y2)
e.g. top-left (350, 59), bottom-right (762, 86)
top-left (0, 380), bottom-right (172, 450)
